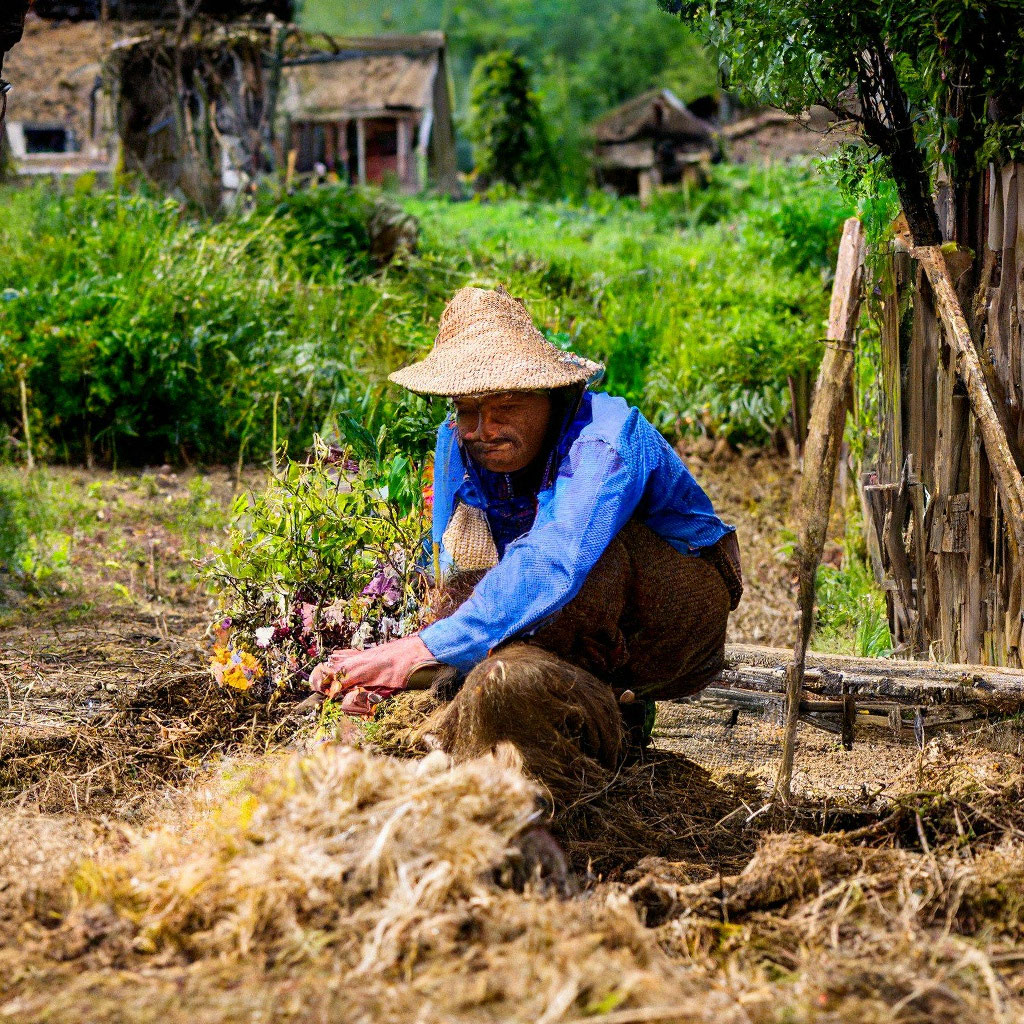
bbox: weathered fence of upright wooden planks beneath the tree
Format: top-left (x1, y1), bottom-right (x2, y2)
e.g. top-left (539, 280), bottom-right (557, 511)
top-left (861, 163), bottom-right (1024, 667)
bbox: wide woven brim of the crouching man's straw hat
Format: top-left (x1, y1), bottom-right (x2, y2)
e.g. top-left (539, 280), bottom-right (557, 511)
top-left (388, 346), bottom-right (604, 397)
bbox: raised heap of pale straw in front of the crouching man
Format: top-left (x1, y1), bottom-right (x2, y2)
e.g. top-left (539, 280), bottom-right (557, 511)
top-left (66, 745), bottom-right (537, 973)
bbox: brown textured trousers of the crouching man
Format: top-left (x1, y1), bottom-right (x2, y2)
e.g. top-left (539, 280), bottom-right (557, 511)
top-left (430, 522), bottom-right (730, 806)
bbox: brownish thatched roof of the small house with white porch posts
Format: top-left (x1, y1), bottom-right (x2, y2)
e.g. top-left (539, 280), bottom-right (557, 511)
top-left (283, 32), bottom-right (444, 121)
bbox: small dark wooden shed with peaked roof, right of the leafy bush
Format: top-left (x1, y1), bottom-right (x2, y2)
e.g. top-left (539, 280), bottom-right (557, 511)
top-left (593, 89), bottom-right (721, 199)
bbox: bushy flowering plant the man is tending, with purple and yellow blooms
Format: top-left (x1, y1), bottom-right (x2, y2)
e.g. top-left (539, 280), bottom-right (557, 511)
top-left (204, 437), bottom-right (429, 696)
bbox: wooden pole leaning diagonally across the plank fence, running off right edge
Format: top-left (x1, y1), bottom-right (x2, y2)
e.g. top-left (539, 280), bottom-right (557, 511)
top-left (910, 246), bottom-right (1024, 557)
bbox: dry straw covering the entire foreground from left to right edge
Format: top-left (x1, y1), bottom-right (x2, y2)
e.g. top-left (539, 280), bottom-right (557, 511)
top-left (0, 744), bottom-right (1024, 1024)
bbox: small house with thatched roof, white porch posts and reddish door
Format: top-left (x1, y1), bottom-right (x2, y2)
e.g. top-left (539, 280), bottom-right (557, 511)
top-left (281, 32), bottom-right (459, 195)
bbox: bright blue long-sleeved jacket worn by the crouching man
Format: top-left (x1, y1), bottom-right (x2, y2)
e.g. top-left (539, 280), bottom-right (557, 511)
top-left (420, 392), bottom-right (734, 672)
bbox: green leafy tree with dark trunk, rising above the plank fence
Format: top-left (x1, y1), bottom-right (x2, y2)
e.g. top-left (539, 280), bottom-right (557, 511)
top-left (659, 0), bottom-right (1024, 244)
